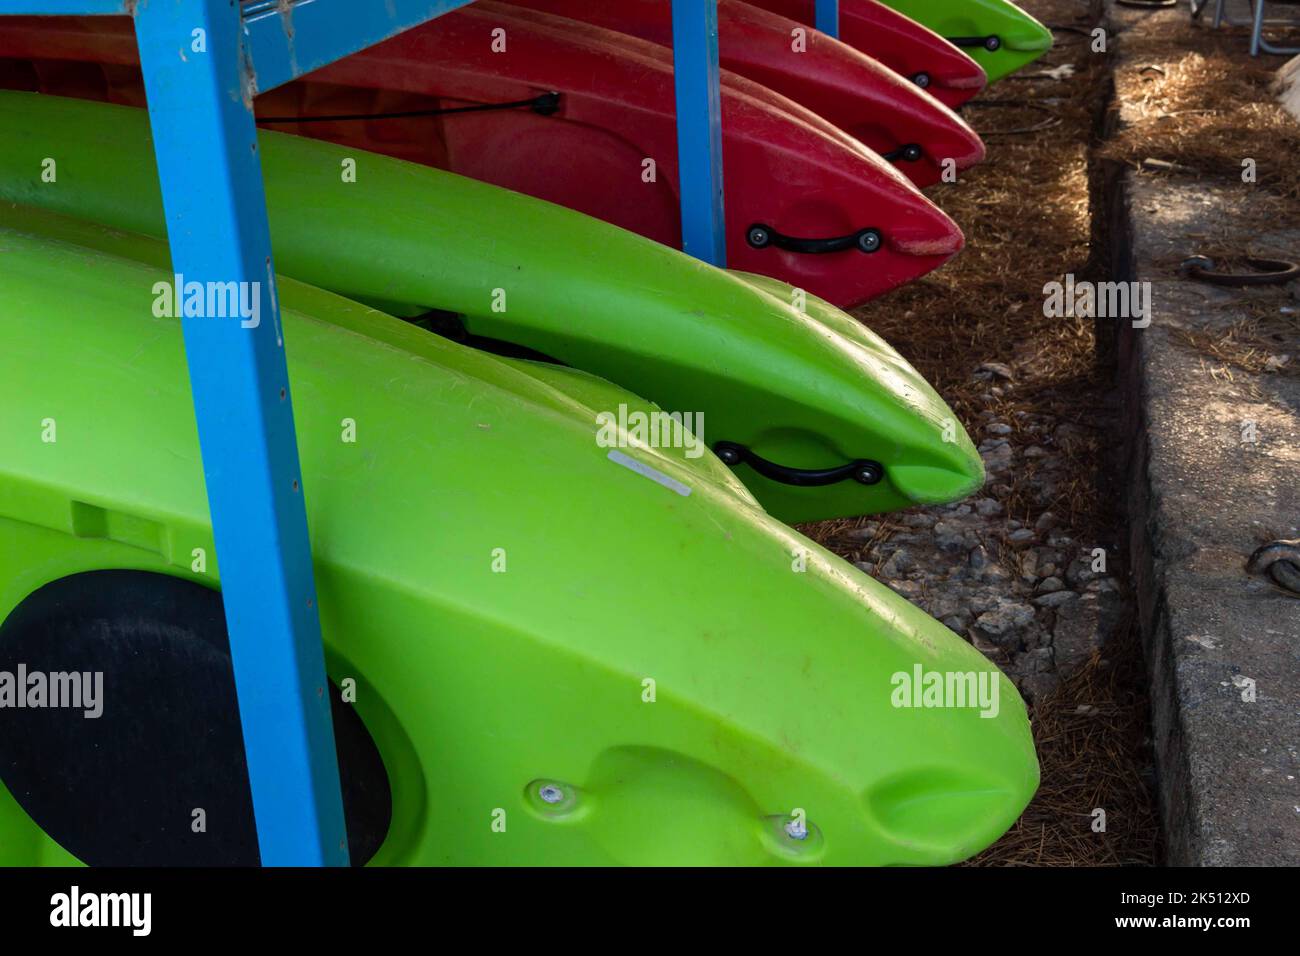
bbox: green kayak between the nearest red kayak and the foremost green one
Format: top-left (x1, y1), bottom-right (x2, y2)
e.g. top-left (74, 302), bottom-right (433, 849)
top-left (0, 92), bottom-right (983, 523)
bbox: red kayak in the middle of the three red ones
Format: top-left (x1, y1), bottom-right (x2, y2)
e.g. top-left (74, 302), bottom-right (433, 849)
top-left (501, 0), bottom-right (984, 187)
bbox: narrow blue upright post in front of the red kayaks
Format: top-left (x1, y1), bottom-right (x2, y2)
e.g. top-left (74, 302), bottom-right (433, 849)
top-left (672, 0), bottom-right (727, 267)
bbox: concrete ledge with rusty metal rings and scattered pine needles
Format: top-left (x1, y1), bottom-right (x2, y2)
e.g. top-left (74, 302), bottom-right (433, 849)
top-left (1109, 0), bottom-right (1300, 866)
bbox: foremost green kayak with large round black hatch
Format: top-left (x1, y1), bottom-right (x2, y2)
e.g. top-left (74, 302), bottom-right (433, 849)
top-left (0, 217), bottom-right (1037, 865)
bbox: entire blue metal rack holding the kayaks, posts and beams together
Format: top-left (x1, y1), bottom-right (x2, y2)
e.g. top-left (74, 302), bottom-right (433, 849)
top-left (0, 0), bottom-right (839, 866)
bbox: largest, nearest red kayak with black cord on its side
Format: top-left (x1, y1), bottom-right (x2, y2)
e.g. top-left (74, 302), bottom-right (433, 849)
top-left (0, 3), bottom-right (962, 308)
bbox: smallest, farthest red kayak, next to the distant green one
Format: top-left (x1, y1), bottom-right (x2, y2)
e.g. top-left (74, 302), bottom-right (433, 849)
top-left (750, 0), bottom-right (988, 108)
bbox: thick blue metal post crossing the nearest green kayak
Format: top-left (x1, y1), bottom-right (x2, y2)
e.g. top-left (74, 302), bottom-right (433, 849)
top-left (135, 0), bottom-right (348, 866)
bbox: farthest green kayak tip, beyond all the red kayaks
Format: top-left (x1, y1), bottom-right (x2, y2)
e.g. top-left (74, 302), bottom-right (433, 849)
top-left (881, 0), bottom-right (1052, 83)
